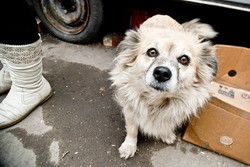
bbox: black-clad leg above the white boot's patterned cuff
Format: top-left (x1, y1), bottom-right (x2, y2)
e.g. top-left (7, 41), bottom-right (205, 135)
top-left (0, 0), bottom-right (39, 45)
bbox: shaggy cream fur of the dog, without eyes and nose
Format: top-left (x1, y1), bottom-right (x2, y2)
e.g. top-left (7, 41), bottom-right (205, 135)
top-left (110, 15), bottom-right (217, 159)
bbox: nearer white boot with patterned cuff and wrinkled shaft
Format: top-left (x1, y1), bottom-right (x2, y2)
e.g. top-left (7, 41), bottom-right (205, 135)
top-left (0, 36), bottom-right (52, 129)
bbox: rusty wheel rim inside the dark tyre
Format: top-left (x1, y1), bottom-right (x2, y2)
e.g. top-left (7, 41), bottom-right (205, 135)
top-left (40, 0), bottom-right (90, 34)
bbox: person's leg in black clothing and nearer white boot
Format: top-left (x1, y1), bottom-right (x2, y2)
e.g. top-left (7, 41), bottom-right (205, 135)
top-left (0, 0), bottom-right (52, 129)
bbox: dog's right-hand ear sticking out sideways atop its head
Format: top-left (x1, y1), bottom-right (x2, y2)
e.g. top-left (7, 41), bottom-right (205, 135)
top-left (182, 19), bottom-right (218, 40)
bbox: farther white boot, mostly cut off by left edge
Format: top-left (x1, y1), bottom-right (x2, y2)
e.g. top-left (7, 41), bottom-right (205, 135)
top-left (0, 58), bottom-right (11, 95)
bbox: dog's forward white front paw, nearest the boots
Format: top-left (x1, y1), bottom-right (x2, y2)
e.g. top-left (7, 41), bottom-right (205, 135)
top-left (119, 142), bottom-right (137, 159)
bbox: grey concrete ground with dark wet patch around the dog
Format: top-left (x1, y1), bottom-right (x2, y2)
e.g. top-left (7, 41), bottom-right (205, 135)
top-left (0, 35), bottom-right (246, 167)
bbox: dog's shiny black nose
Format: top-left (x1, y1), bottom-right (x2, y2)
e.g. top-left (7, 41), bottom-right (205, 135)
top-left (153, 66), bottom-right (172, 82)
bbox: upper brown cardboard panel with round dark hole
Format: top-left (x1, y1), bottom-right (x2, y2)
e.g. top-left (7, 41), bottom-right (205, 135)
top-left (215, 45), bottom-right (250, 91)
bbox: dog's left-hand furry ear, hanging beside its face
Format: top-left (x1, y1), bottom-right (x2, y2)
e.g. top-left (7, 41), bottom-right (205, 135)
top-left (116, 30), bottom-right (140, 66)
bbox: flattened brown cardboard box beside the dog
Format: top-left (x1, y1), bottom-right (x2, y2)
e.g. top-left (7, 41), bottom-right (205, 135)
top-left (183, 45), bottom-right (250, 165)
